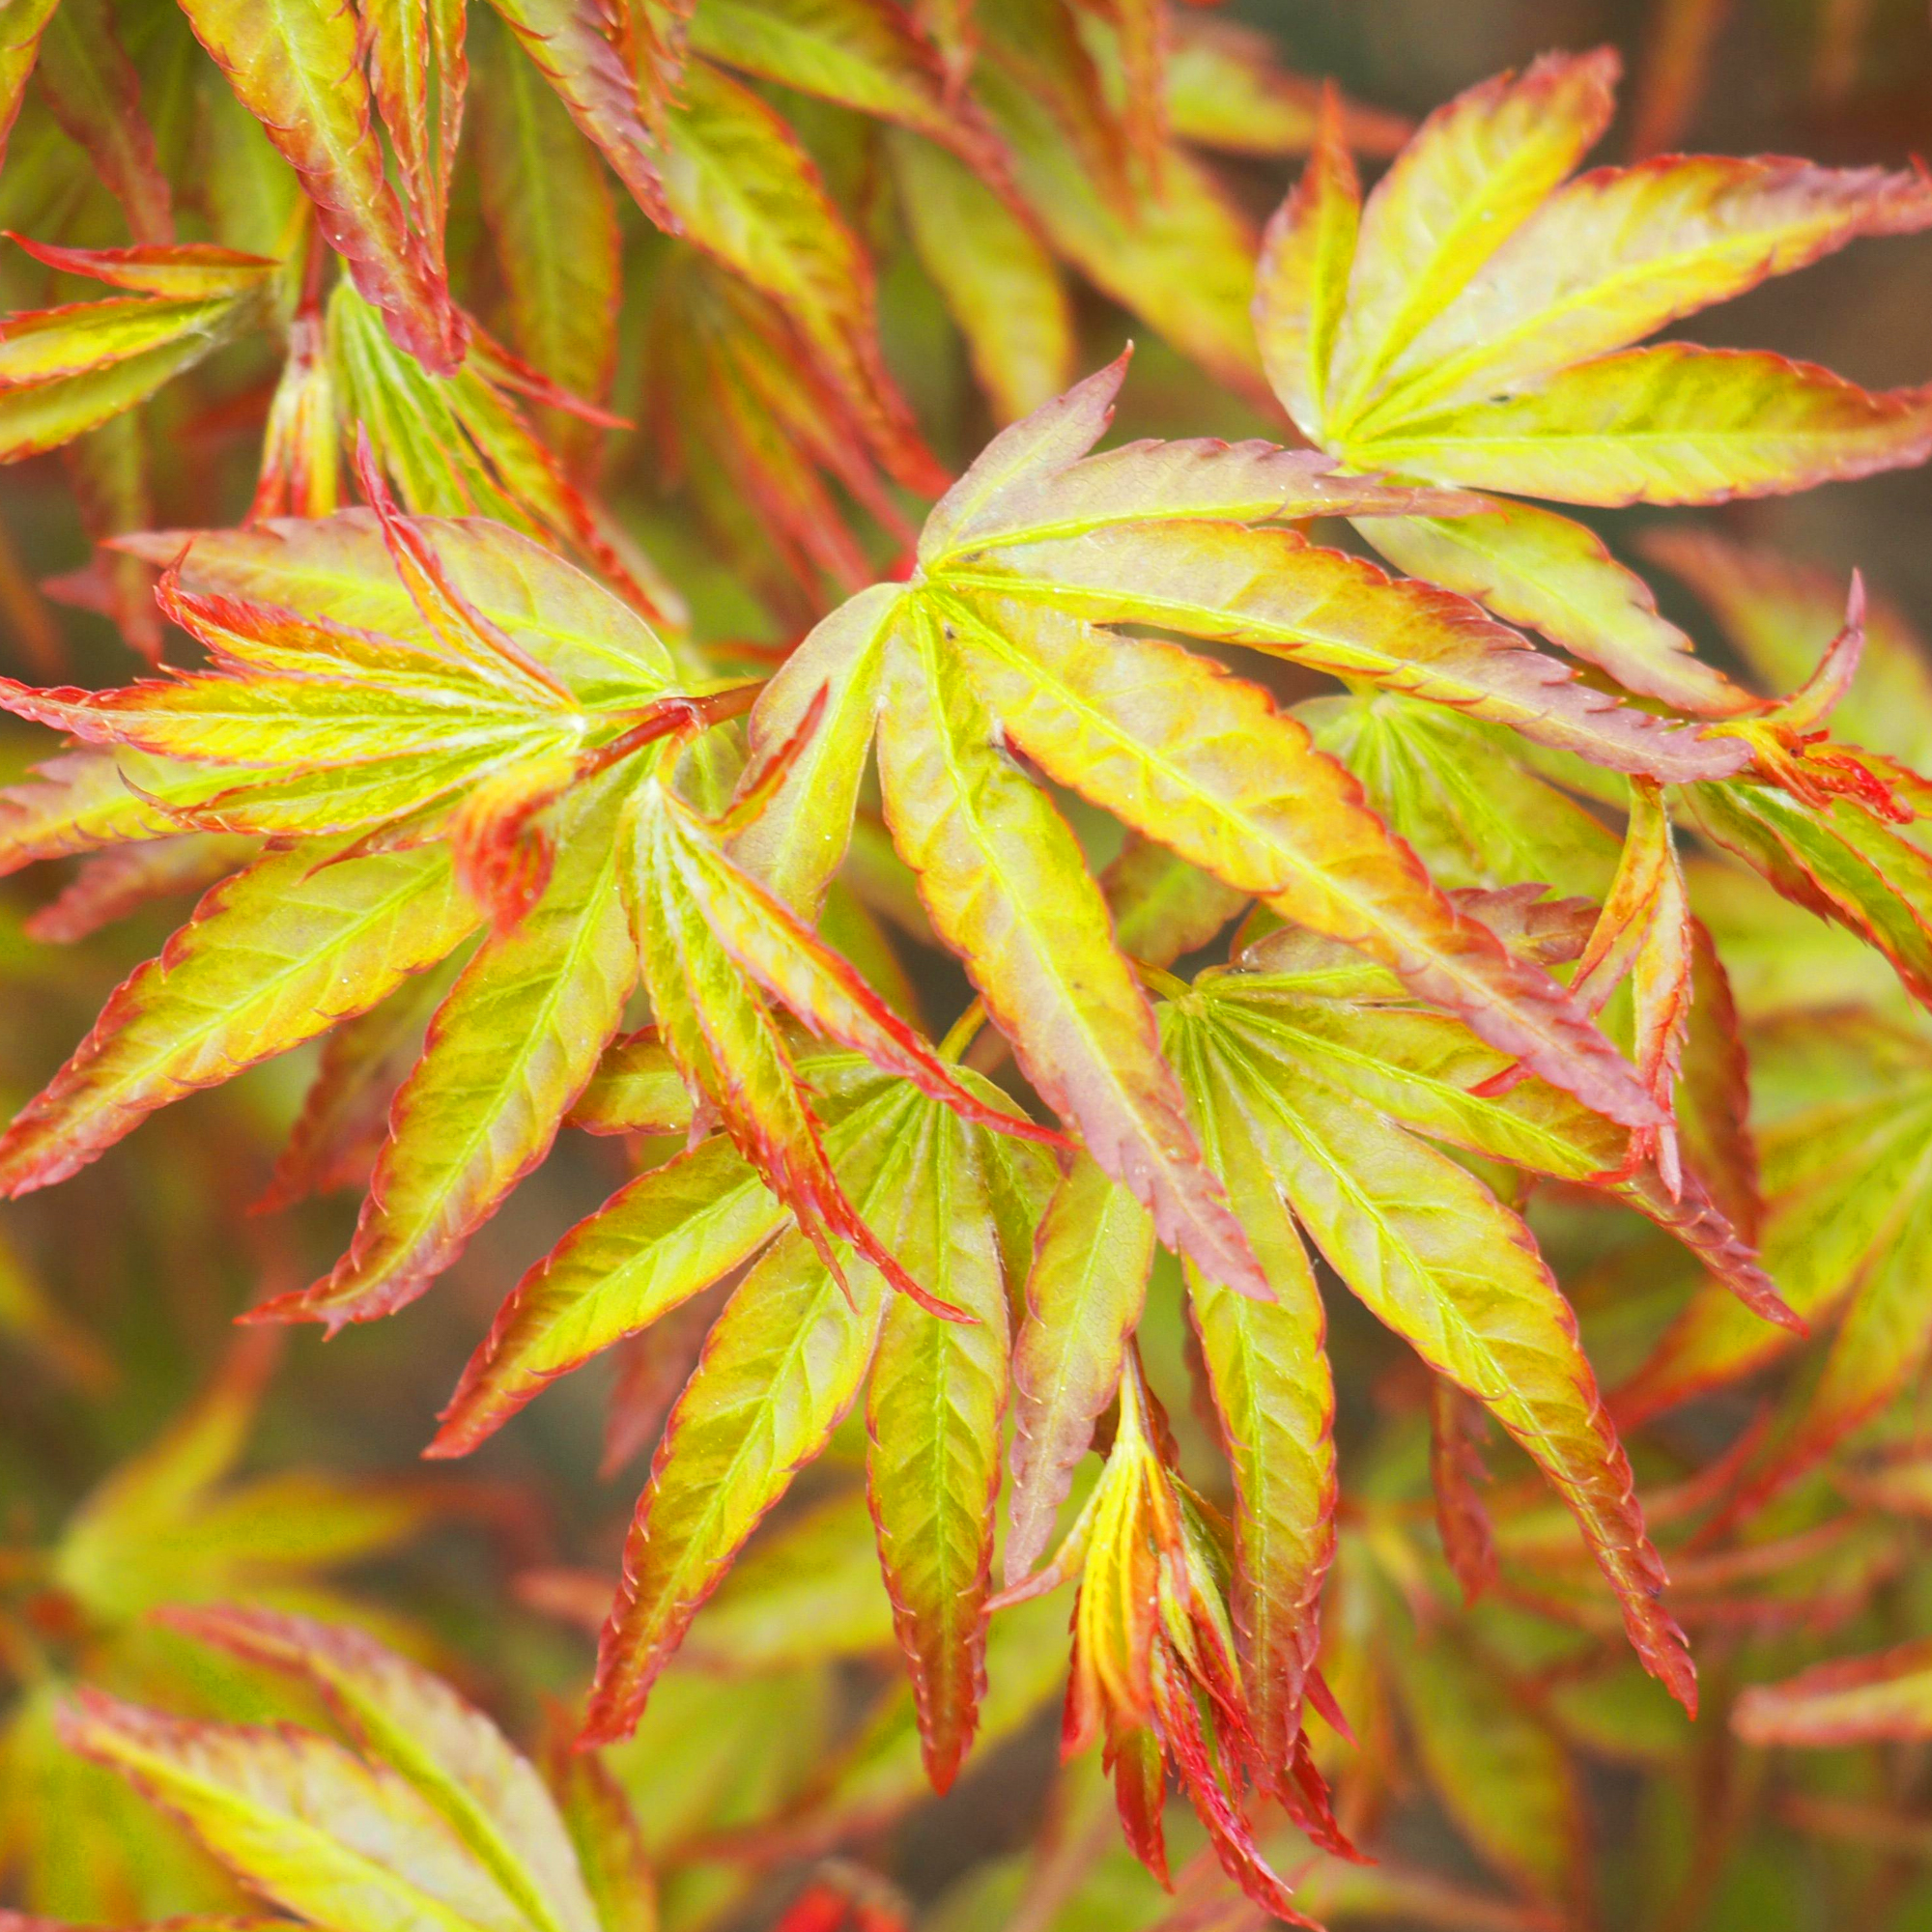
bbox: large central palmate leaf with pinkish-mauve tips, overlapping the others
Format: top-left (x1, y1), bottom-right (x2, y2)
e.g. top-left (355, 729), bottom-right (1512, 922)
top-left (742, 365), bottom-right (1737, 1293)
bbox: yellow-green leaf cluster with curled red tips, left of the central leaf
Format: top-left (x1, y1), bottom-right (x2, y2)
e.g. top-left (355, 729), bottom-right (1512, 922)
top-left (0, 483), bottom-right (1055, 1360)
